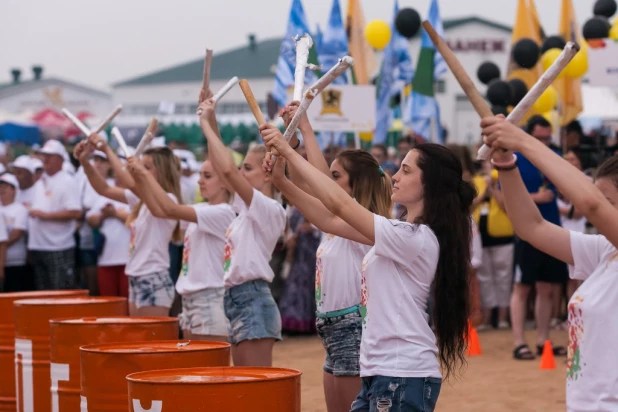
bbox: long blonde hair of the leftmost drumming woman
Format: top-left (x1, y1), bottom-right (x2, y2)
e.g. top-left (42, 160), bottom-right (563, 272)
top-left (127, 147), bottom-right (182, 242)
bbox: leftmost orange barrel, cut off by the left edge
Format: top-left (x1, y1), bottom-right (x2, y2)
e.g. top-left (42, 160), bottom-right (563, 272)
top-left (0, 290), bottom-right (88, 412)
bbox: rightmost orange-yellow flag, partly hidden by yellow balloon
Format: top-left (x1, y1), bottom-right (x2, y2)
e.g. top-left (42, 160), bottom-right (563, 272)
top-left (554, 0), bottom-right (584, 126)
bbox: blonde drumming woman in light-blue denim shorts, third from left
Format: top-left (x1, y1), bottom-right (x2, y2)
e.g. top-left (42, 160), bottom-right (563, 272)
top-left (198, 99), bottom-right (286, 366)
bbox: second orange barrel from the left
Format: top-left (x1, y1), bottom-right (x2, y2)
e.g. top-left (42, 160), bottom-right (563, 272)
top-left (13, 297), bottom-right (127, 412)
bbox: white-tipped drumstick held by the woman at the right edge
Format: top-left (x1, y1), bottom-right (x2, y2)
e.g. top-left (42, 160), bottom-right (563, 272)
top-left (477, 42), bottom-right (579, 160)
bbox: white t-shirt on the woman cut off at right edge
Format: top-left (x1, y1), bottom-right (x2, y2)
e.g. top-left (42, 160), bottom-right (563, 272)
top-left (567, 231), bottom-right (618, 412)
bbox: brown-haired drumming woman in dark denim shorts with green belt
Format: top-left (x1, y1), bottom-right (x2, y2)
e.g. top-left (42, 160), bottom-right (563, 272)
top-left (265, 103), bottom-right (393, 412)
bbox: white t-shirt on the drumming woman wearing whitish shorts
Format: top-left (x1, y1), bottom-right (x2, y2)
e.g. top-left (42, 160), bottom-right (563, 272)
top-left (176, 203), bottom-right (236, 295)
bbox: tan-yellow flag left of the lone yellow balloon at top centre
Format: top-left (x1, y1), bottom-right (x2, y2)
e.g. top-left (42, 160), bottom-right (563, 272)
top-left (346, 0), bottom-right (377, 84)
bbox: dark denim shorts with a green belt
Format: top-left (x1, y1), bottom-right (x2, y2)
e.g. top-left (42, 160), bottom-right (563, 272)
top-left (316, 311), bottom-right (363, 376)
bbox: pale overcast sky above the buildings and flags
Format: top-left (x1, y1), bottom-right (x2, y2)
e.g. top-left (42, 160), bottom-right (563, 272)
top-left (0, 0), bottom-right (594, 89)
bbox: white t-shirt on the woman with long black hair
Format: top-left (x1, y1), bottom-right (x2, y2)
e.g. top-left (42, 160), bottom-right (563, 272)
top-left (360, 215), bottom-right (441, 378)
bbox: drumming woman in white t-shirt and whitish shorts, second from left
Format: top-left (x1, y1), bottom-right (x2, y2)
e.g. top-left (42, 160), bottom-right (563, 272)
top-left (128, 158), bottom-right (236, 341)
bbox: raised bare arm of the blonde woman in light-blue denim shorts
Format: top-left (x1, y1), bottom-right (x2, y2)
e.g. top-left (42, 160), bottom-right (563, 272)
top-left (198, 99), bottom-right (253, 206)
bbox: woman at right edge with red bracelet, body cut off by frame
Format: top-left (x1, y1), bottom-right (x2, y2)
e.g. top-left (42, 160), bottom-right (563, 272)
top-left (481, 116), bottom-right (618, 412)
